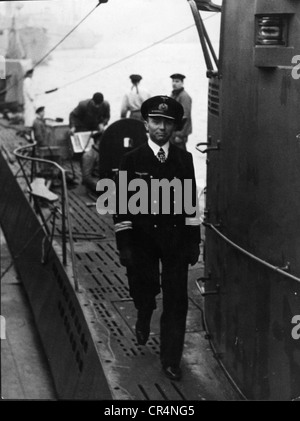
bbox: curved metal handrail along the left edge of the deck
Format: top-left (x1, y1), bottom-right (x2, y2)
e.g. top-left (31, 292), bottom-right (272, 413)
top-left (13, 142), bottom-right (80, 292)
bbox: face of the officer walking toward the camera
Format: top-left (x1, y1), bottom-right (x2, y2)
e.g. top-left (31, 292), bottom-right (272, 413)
top-left (145, 117), bottom-right (175, 146)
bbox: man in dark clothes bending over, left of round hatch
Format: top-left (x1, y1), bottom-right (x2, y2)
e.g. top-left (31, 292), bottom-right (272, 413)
top-left (69, 92), bottom-right (110, 133)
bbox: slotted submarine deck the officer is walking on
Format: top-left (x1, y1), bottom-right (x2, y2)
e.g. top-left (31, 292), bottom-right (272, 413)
top-left (0, 122), bottom-right (240, 401)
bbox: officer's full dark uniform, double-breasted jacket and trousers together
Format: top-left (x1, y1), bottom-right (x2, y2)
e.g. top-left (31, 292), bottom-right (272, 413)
top-left (115, 143), bottom-right (200, 366)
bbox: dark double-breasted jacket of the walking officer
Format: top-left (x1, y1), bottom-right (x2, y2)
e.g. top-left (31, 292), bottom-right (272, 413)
top-left (115, 143), bottom-right (200, 253)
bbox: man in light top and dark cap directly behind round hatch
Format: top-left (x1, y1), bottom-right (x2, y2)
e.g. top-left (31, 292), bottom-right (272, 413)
top-left (121, 74), bottom-right (150, 120)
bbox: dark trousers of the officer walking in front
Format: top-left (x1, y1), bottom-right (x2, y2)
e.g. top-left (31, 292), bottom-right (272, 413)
top-left (127, 223), bottom-right (188, 366)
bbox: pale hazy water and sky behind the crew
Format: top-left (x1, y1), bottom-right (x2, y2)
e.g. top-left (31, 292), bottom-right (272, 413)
top-left (0, 0), bottom-right (221, 186)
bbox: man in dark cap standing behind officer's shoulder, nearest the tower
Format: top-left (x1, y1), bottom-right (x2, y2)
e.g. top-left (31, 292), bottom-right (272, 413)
top-left (170, 73), bottom-right (192, 150)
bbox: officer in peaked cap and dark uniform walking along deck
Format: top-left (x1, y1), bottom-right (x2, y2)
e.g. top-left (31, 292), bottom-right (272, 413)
top-left (115, 96), bottom-right (200, 380)
